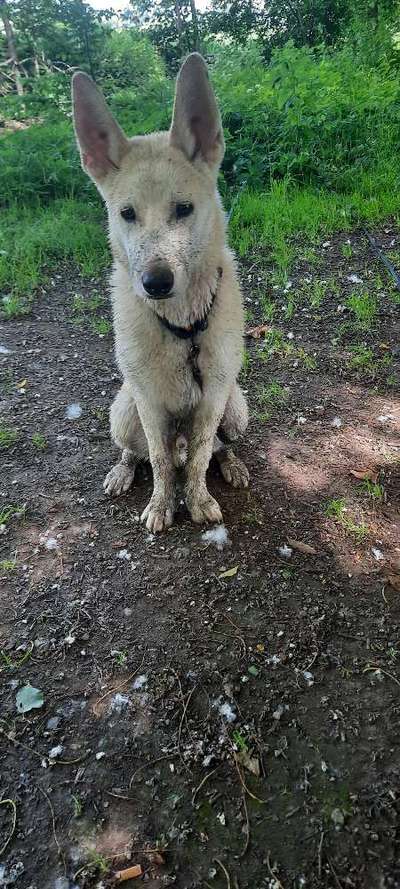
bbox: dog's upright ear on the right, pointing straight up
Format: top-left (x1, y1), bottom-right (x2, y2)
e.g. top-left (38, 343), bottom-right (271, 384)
top-left (170, 52), bottom-right (225, 168)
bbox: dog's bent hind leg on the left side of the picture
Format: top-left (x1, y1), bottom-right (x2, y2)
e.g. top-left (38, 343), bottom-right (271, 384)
top-left (103, 383), bottom-right (149, 496)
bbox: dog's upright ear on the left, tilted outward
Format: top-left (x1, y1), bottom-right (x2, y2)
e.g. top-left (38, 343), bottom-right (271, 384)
top-left (72, 71), bottom-right (129, 181)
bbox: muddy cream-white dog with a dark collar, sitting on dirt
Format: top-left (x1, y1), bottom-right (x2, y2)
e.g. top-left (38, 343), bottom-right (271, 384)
top-left (72, 53), bottom-right (249, 533)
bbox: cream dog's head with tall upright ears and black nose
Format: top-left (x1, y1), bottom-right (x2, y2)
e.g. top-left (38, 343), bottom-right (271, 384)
top-left (72, 53), bottom-right (224, 299)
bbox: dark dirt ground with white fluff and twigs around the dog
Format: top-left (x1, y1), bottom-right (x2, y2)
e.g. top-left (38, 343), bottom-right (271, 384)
top-left (0, 225), bottom-right (400, 889)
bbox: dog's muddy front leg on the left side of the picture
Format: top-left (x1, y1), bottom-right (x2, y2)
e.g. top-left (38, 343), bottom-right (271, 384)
top-left (136, 399), bottom-right (175, 533)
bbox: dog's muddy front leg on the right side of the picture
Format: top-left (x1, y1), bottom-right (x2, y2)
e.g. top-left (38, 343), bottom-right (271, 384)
top-left (185, 391), bottom-right (229, 522)
